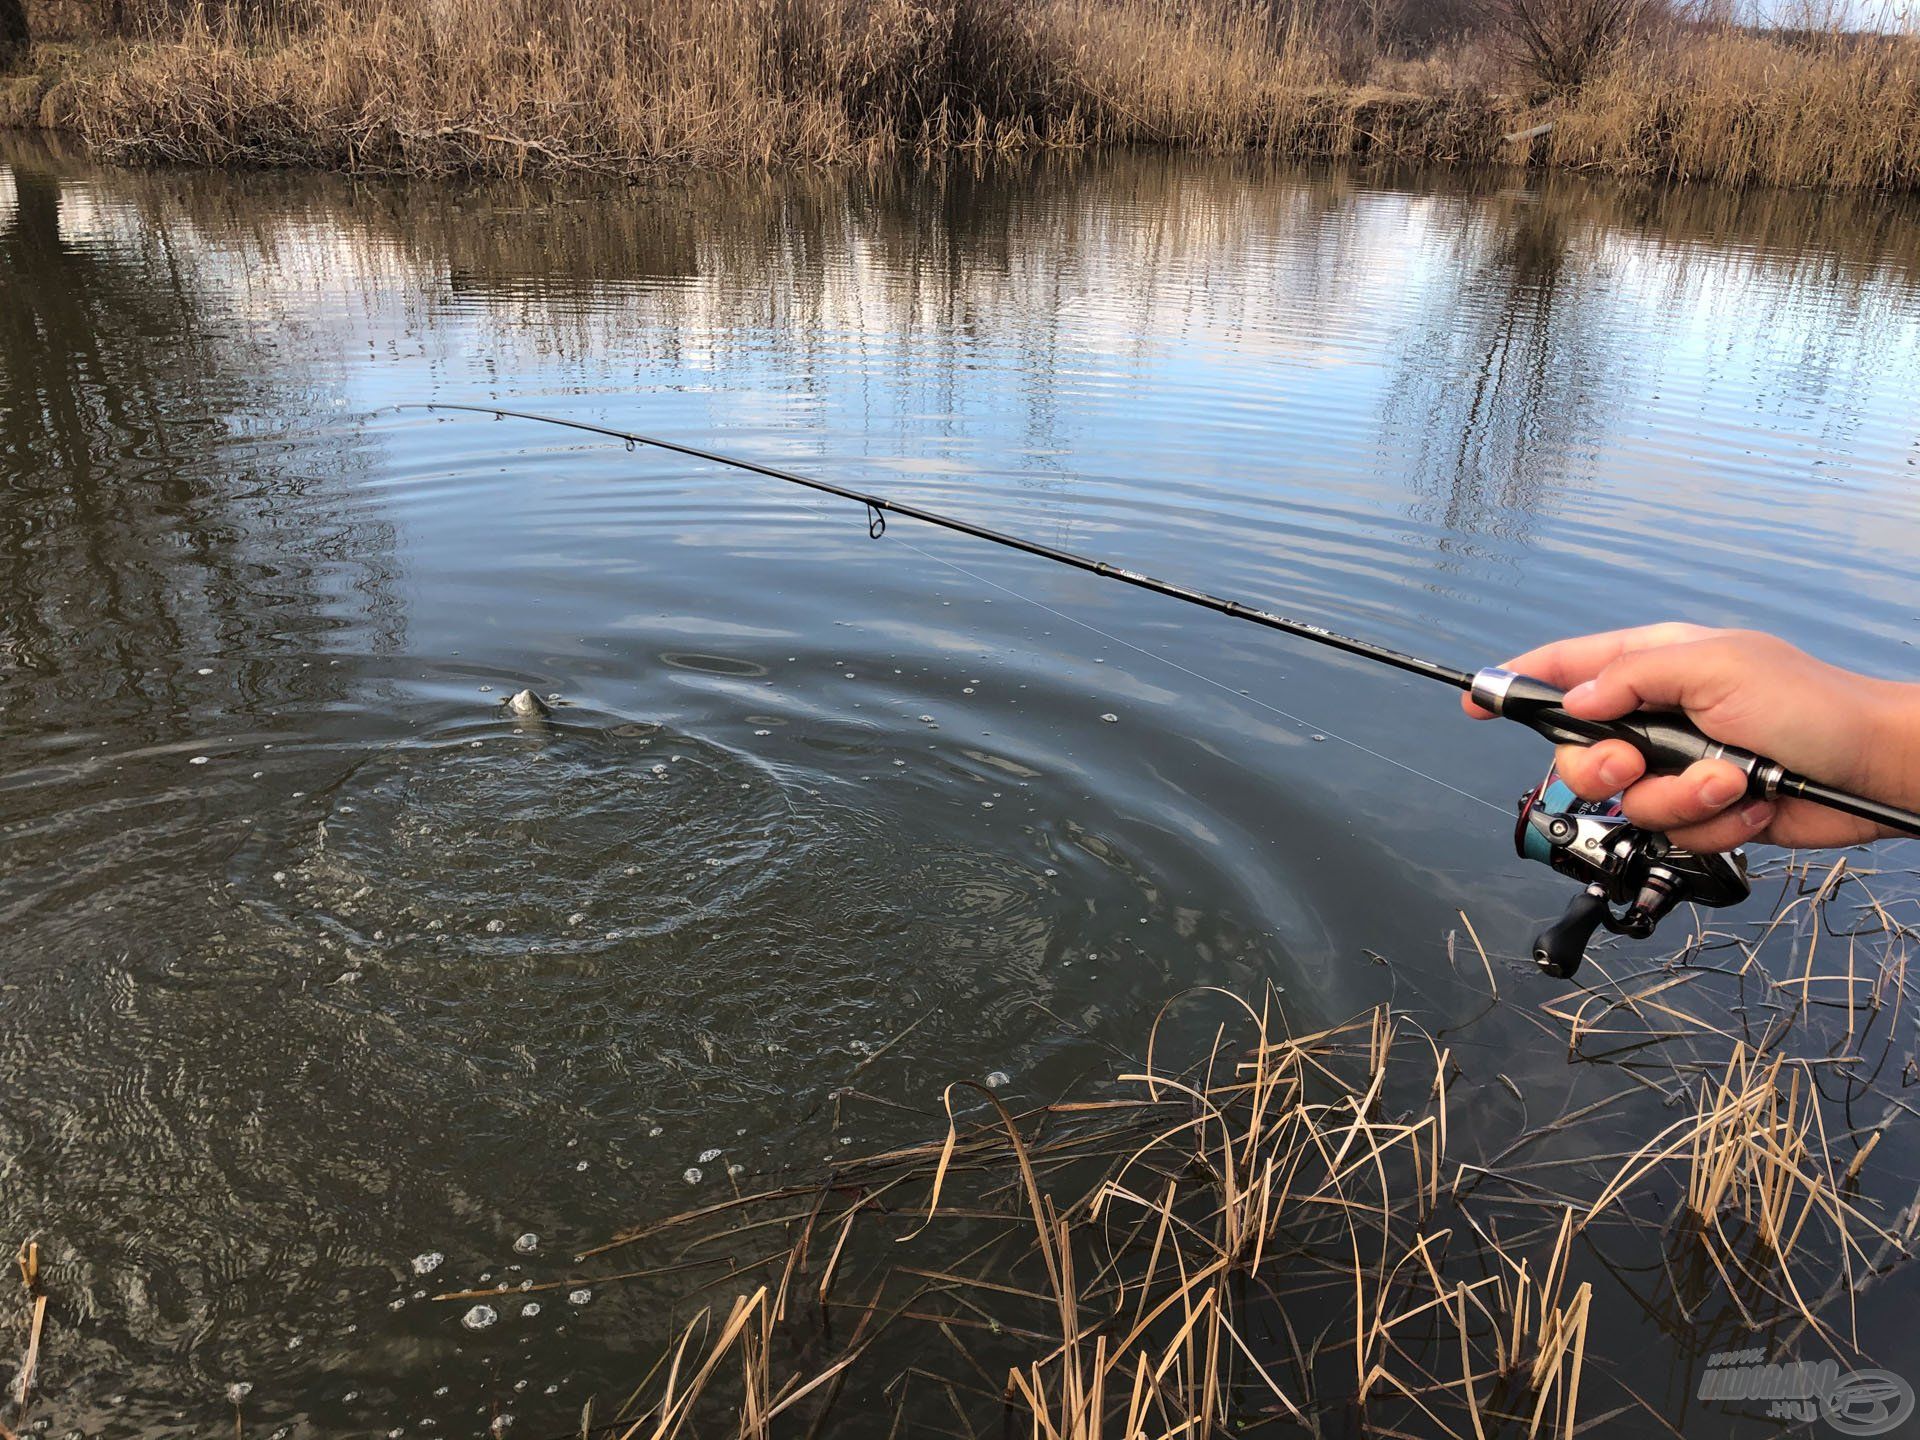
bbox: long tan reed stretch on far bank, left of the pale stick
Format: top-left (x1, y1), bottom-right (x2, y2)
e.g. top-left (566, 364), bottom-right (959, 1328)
top-left (45, 0), bottom-right (1494, 173)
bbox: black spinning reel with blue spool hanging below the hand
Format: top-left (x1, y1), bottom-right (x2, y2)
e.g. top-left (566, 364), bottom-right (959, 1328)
top-left (1513, 770), bottom-right (1751, 979)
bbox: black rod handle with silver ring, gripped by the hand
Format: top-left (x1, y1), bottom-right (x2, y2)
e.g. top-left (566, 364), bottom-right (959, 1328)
top-left (1467, 666), bottom-right (1920, 835)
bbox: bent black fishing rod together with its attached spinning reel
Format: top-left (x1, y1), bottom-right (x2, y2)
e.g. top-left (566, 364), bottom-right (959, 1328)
top-left (396, 401), bottom-right (1920, 977)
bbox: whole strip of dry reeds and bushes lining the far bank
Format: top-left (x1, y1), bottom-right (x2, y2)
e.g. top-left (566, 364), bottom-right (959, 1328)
top-left (0, 0), bottom-right (1920, 188)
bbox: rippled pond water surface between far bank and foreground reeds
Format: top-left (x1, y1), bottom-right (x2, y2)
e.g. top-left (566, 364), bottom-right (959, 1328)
top-left (0, 142), bottom-right (1920, 1436)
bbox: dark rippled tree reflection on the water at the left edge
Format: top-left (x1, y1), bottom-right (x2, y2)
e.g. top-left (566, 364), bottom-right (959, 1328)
top-left (0, 141), bottom-right (399, 732)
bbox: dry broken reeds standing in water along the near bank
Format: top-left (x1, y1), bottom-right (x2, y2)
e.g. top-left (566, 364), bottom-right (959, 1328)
top-left (420, 860), bottom-right (1920, 1440)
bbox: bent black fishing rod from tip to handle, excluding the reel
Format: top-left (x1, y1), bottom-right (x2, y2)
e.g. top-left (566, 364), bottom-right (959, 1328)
top-left (412, 403), bottom-right (1920, 835)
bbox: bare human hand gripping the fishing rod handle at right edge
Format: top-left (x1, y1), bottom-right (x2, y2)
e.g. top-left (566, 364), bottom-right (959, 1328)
top-left (1461, 624), bottom-right (1920, 851)
